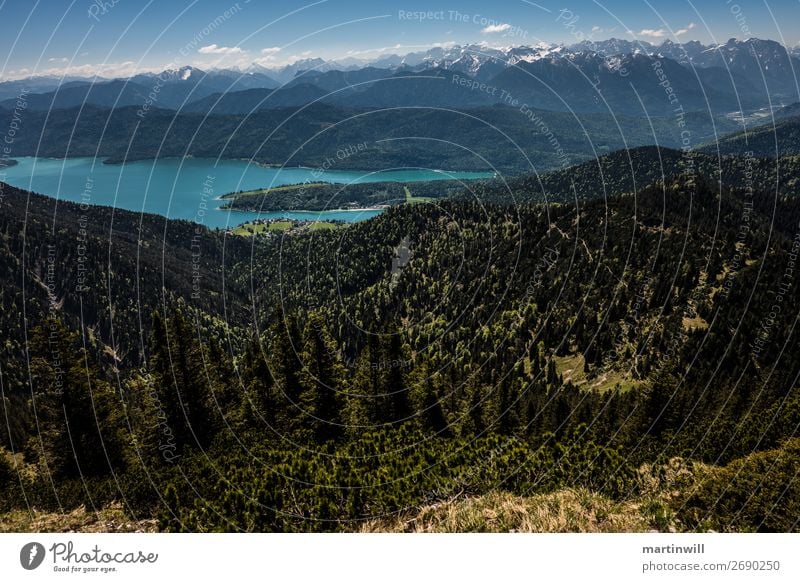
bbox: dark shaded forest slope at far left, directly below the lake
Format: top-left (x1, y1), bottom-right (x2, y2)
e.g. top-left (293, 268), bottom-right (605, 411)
top-left (0, 184), bottom-right (249, 362)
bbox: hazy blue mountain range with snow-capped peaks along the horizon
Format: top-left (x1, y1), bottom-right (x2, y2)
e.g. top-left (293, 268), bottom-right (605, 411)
top-left (0, 38), bottom-right (800, 116)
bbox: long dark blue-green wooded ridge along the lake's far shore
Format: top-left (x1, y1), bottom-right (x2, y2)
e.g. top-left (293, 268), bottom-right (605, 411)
top-left (0, 103), bottom-right (740, 173)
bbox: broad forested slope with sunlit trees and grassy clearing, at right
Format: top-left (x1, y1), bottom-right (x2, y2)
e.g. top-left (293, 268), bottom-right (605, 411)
top-left (241, 181), bottom-right (796, 456)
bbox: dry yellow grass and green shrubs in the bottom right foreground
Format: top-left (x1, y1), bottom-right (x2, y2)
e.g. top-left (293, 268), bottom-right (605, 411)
top-left (361, 438), bottom-right (800, 533)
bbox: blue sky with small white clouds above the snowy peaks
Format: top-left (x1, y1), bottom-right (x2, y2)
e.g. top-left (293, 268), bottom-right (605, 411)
top-left (0, 0), bottom-right (800, 78)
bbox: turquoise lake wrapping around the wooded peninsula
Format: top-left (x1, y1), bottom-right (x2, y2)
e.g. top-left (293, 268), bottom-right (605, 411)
top-left (0, 157), bottom-right (491, 228)
